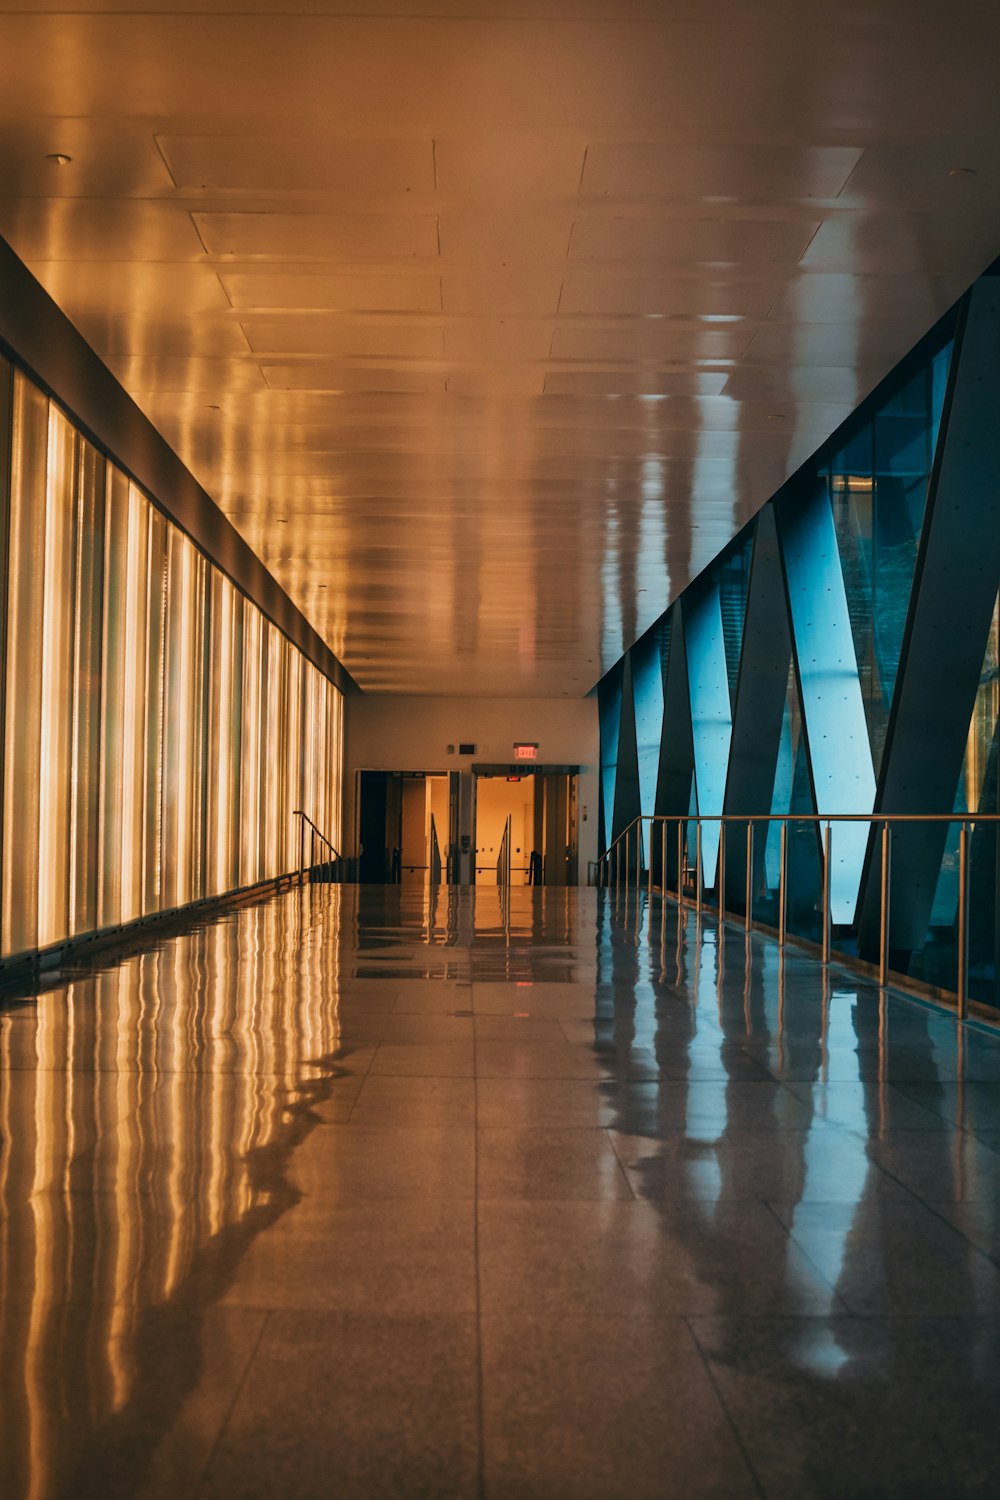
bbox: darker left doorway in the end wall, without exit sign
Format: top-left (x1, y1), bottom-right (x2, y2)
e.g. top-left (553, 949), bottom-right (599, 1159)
top-left (357, 771), bottom-right (459, 885)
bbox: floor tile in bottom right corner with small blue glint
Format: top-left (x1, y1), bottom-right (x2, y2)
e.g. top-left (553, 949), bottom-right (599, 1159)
top-left (691, 1317), bottom-right (1000, 1500)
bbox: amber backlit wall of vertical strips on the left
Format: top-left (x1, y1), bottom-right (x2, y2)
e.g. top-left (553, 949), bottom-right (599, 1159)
top-left (0, 360), bottom-right (342, 957)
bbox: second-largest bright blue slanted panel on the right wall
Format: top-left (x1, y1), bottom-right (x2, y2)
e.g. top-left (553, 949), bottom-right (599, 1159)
top-left (682, 581), bottom-right (733, 885)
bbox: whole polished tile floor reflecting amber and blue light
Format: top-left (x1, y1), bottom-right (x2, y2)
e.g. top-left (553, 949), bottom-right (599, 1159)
top-left (0, 887), bottom-right (1000, 1500)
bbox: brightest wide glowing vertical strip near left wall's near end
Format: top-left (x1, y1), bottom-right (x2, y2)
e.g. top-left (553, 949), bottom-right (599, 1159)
top-left (37, 404), bottom-right (79, 948)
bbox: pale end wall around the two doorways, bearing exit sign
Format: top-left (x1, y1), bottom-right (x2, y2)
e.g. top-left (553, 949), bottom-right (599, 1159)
top-left (343, 693), bottom-right (600, 882)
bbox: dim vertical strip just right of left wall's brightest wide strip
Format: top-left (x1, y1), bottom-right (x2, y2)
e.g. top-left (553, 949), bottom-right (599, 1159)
top-left (69, 441), bottom-right (105, 933)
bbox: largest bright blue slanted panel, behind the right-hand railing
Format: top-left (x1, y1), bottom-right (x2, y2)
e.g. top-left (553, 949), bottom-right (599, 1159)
top-left (777, 480), bottom-right (876, 924)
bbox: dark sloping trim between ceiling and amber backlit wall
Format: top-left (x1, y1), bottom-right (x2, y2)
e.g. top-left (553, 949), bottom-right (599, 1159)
top-left (0, 239), bottom-right (361, 693)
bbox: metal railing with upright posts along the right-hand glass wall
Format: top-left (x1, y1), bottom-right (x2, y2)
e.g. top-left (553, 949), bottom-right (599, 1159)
top-left (597, 813), bottom-right (1000, 1019)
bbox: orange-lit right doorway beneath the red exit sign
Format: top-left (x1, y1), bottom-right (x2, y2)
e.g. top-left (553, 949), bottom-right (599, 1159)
top-left (474, 767), bottom-right (577, 887)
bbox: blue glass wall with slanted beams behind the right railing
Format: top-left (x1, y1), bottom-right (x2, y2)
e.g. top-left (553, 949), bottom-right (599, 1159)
top-left (598, 273), bottom-right (1000, 1010)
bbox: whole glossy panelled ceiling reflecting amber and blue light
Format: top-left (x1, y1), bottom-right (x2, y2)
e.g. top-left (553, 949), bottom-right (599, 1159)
top-left (0, 0), bottom-right (1000, 695)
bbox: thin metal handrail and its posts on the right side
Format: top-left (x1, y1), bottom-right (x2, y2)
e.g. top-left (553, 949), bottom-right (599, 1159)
top-left (597, 813), bottom-right (1000, 1020)
